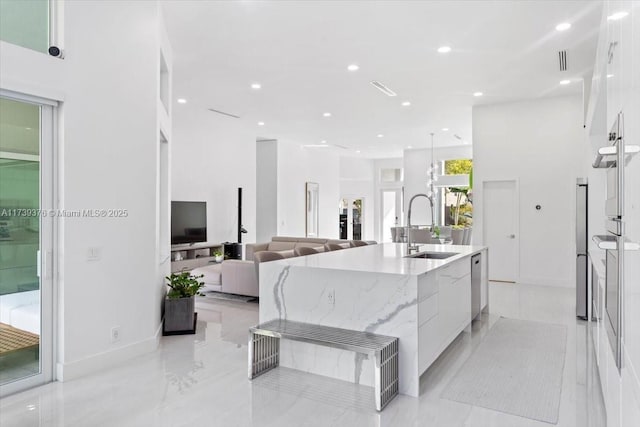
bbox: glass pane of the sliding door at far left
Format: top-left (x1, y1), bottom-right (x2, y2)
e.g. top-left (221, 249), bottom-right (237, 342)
top-left (0, 98), bottom-right (41, 385)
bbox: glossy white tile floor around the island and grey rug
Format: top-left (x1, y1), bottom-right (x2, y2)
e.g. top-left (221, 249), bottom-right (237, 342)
top-left (0, 283), bottom-right (605, 427)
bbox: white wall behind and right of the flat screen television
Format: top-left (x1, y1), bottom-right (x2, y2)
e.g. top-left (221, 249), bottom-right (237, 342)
top-left (171, 108), bottom-right (256, 243)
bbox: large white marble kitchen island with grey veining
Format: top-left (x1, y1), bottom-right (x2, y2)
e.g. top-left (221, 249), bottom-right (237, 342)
top-left (260, 243), bottom-right (488, 396)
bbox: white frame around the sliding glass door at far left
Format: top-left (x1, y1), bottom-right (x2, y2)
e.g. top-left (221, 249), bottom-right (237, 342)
top-left (0, 89), bottom-right (59, 397)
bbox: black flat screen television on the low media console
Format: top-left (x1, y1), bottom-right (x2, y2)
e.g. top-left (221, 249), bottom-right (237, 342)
top-left (171, 201), bottom-right (207, 245)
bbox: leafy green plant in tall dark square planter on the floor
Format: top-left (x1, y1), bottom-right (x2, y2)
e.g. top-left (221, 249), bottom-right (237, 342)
top-left (163, 271), bottom-right (204, 335)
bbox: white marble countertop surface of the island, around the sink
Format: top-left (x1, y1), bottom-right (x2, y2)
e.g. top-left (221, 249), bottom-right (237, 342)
top-left (273, 243), bottom-right (486, 275)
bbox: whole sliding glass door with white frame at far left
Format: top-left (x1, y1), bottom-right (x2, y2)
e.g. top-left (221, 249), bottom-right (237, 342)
top-left (0, 93), bottom-right (55, 395)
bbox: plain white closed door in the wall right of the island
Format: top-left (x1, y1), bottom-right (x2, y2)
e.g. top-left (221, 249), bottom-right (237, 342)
top-left (482, 181), bottom-right (519, 282)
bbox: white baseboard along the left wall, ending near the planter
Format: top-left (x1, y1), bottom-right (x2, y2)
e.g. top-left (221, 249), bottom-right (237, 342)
top-left (55, 323), bottom-right (162, 381)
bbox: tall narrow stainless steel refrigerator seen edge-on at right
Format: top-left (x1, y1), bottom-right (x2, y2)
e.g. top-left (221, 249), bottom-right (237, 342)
top-left (576, 178), bottom-right (589, 319)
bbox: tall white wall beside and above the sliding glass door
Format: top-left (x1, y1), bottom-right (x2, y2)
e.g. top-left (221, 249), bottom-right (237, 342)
top-left (0, 1), bottom-right (168, 379)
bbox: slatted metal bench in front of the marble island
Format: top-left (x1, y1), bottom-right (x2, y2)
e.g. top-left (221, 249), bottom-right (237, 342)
top-left (249, 319), bottom-right (398, 411)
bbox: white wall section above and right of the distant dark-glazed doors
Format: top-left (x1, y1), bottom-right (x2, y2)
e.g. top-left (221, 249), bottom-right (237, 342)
top-left (336, 157), bottom-right (376, 240)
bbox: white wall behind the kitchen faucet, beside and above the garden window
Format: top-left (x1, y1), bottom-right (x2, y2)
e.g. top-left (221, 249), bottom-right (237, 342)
top-left (404, 146), bottom-right (473, 225)
